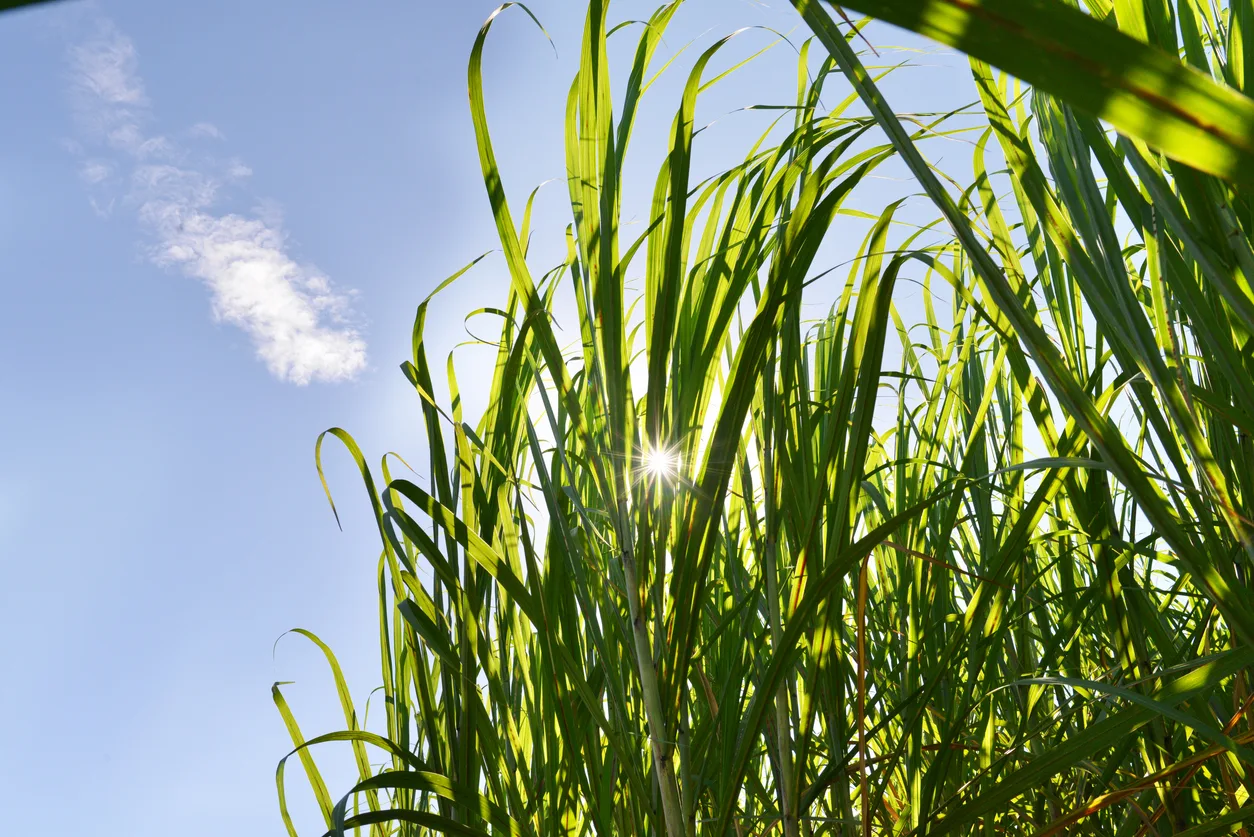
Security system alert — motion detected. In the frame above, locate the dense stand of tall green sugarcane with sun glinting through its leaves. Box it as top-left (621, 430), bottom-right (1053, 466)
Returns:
top-left (273, 0), bottom-right (1254, 837)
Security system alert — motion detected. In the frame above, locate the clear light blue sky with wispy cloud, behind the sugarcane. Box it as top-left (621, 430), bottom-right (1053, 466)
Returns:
top-left (0, 0), bottom-right (973, 837)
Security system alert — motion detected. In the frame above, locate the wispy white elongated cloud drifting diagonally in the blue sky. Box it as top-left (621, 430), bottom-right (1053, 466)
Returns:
top-left (69, 21), bottom-right (366, 384)
